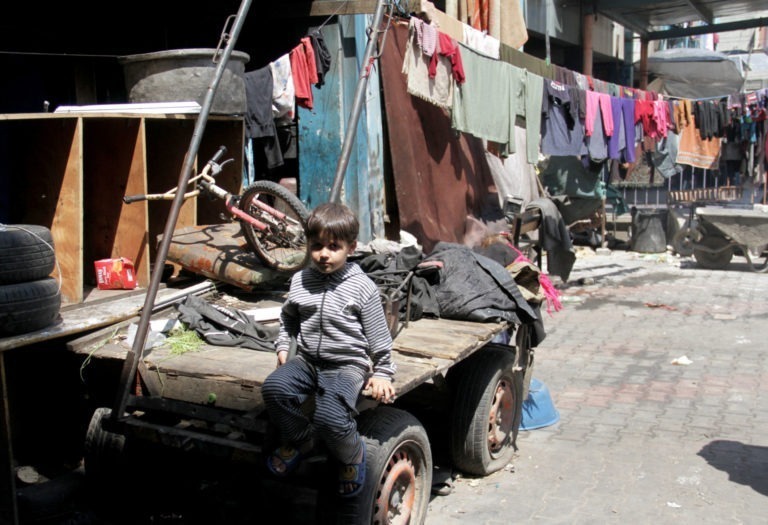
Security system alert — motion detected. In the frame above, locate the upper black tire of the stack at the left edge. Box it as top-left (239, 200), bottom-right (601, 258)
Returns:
top-left (0, 224), bottom-right (56, 284)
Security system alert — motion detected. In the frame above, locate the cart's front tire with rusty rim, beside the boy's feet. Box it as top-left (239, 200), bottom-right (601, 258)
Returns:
top-left (318, 407), bottom-right (432, 525)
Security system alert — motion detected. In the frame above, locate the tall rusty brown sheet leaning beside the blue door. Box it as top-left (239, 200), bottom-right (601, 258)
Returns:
top-left (380, 22), bottom-right (503, 252)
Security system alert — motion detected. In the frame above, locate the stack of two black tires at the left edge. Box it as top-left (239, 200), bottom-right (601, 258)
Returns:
top-left (0, 224), bottom-right (61, 337)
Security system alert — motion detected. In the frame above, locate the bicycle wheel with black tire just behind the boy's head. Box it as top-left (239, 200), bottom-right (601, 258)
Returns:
top-left (238, 180), bottom-right (309, 272)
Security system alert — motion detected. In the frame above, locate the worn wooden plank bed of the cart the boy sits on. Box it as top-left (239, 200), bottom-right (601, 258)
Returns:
top-left (67, 302), bottom-right (508, 412)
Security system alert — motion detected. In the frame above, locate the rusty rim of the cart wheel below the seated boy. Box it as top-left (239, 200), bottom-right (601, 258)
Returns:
top-left (373, 443), bottom-right (419, 525)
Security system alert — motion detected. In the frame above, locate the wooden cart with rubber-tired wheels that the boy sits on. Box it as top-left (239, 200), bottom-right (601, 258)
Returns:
top-left (68, 225), bottom-right (533, 523)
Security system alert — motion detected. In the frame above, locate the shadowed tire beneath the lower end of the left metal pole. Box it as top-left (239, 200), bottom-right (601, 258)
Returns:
top-left (83, 407), bottom-right (126, 493)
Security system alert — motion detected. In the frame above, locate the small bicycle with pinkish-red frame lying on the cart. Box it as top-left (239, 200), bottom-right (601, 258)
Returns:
top-left (123, 146), bottom-right (309, 272)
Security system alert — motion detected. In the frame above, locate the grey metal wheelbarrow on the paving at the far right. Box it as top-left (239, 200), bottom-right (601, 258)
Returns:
top-left (690, 205), bottom-right (768, 273)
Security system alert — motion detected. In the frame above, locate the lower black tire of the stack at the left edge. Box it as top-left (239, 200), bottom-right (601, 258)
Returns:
top-left (0, 277), bottom-right (61, 335)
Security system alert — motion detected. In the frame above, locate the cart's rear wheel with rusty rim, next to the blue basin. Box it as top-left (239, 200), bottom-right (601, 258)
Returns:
top-left (450, 345), bottom-right (522, 476)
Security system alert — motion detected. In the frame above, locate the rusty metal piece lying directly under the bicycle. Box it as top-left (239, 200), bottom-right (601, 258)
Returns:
top-left (167, 223), bottom-right (290, 291)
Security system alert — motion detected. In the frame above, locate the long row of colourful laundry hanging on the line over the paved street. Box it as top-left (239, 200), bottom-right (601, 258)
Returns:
top-left (403, 13), bottom-right (768, 172)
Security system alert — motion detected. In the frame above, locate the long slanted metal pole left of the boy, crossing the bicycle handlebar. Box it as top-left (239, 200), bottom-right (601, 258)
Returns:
top-left (111, 0), bottom-right (251, 420)
